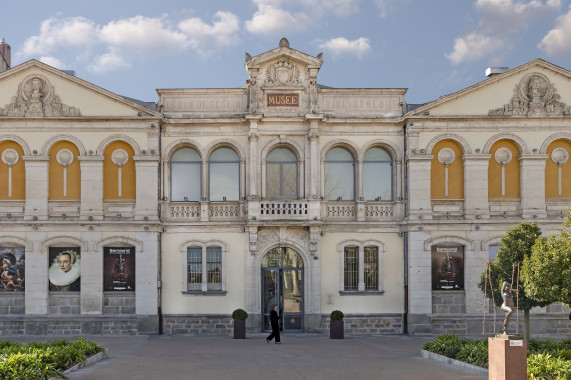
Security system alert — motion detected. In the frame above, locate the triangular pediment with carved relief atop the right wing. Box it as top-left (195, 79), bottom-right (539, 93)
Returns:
top-left (407, 59), bottom-right (571, 117)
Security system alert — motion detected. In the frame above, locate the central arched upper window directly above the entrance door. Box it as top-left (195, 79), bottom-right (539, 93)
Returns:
top-left (266, 148), bottom-right (298, 199)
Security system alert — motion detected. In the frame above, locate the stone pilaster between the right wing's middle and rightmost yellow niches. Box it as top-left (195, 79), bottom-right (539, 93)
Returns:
top-left (520, 154), bottom-right (549, 219)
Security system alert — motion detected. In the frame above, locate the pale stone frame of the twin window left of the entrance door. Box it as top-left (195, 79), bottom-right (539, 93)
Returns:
top-left (180, 240), bottom-right (228, 295)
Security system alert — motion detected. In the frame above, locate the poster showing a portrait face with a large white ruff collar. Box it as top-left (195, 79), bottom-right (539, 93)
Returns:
top-left (48, 247), bottom-right (81, 292)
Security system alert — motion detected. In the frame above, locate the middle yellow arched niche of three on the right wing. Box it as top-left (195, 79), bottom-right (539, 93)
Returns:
top-left (488, 140), bottom-right (520, 199)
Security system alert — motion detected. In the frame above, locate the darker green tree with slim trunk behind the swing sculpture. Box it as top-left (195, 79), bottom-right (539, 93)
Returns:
top-left (478, 223), bottom-right (550, 339)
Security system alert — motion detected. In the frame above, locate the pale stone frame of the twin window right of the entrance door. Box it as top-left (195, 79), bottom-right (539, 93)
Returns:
top-left (337, 240), bottom-right (385, 296)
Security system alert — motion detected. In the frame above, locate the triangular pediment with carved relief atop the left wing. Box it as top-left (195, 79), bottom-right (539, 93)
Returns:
top-left (0, 60), bottom-right (160, 118)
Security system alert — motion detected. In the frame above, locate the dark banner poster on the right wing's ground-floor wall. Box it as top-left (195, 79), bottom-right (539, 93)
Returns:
top-left (431, 245), bottom-right (464, 290)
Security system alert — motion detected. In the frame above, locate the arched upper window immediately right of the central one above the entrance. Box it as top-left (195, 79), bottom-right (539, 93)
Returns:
top-left (325, 148), bottom-right (355, 201)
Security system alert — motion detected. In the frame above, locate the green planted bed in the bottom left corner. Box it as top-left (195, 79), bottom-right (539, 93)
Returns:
top-left (0, 338), bottom-right (105, 380)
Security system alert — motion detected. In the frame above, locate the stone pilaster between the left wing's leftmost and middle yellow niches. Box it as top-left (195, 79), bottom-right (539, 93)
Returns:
top-left (22, 156), bottom-right (50, 220)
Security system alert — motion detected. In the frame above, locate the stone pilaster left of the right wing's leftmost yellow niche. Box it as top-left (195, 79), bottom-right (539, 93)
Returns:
top-left (408, 155), bottom-right (433, 219)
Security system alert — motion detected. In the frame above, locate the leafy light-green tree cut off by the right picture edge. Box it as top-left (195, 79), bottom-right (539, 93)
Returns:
top-left (522, 211), bottom-right (571, 307)
